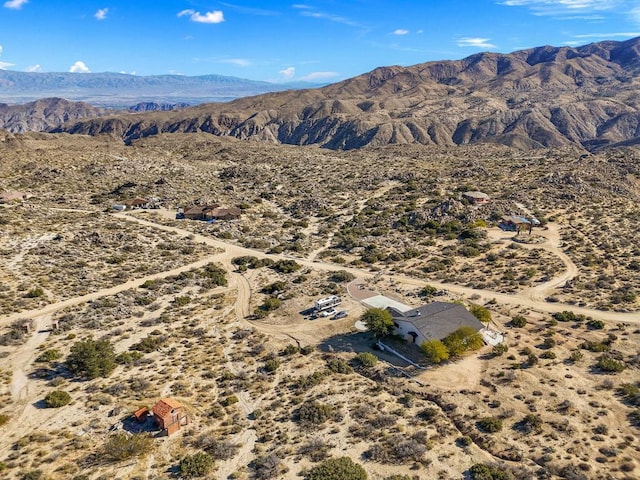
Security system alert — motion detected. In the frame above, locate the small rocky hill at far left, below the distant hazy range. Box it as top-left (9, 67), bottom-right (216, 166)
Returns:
top-left (0, 98), bottom-right (112, 133)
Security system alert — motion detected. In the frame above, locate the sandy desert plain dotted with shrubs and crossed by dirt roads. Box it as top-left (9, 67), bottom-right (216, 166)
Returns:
top-left (0, 128), bottom-right (640, 480)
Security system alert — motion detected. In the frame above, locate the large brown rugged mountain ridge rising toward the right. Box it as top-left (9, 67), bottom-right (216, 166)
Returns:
top-left (56, 38), bottom-right (640, 150)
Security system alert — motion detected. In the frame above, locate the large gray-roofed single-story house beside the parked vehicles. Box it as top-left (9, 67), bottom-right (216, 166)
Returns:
top-left (387, 302), bottom-right (484, 345)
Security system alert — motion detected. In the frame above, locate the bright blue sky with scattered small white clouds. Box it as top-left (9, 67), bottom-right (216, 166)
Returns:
top-left (0, 0), bottom-right (640, 82)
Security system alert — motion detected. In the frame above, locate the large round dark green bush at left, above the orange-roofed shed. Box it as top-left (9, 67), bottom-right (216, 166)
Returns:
top-left (65, 339), bottom-right (116, 380)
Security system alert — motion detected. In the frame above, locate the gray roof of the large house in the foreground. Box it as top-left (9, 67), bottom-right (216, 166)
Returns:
top-left (387, 302), bottom-right (484, 340)
